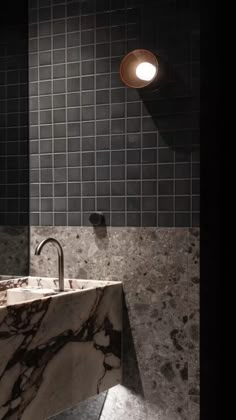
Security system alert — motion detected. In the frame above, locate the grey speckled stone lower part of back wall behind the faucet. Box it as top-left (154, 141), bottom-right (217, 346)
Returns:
top-left (31, 227), bottom-right (199, 420)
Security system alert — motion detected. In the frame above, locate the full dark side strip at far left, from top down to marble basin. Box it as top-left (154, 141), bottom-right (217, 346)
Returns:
top-left (0, 0), bottom-right (29, 276)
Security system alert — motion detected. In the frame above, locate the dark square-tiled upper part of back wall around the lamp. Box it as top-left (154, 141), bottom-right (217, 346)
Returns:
top-left (29, 0), bottom-right (199, 227)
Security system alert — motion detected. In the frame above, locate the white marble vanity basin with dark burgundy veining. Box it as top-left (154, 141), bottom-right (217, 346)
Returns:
top-left (0, 277), bottom-right (123, 420)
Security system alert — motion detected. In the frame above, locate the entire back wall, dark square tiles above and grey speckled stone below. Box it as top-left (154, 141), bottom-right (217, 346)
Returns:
top-left (29, 0), bottom-right (199, 420)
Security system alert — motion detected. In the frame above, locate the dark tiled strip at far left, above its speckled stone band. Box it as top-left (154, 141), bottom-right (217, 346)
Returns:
top-left (0, 1), bottom-right (29, 226)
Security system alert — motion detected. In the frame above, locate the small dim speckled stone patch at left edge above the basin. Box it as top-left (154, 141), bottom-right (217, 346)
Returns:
top-left (0, 226), bottom-right (29, 280)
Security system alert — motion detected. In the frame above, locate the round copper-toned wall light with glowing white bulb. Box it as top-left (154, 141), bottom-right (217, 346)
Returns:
top-left (120, 49), bottom-right (159, 89)
